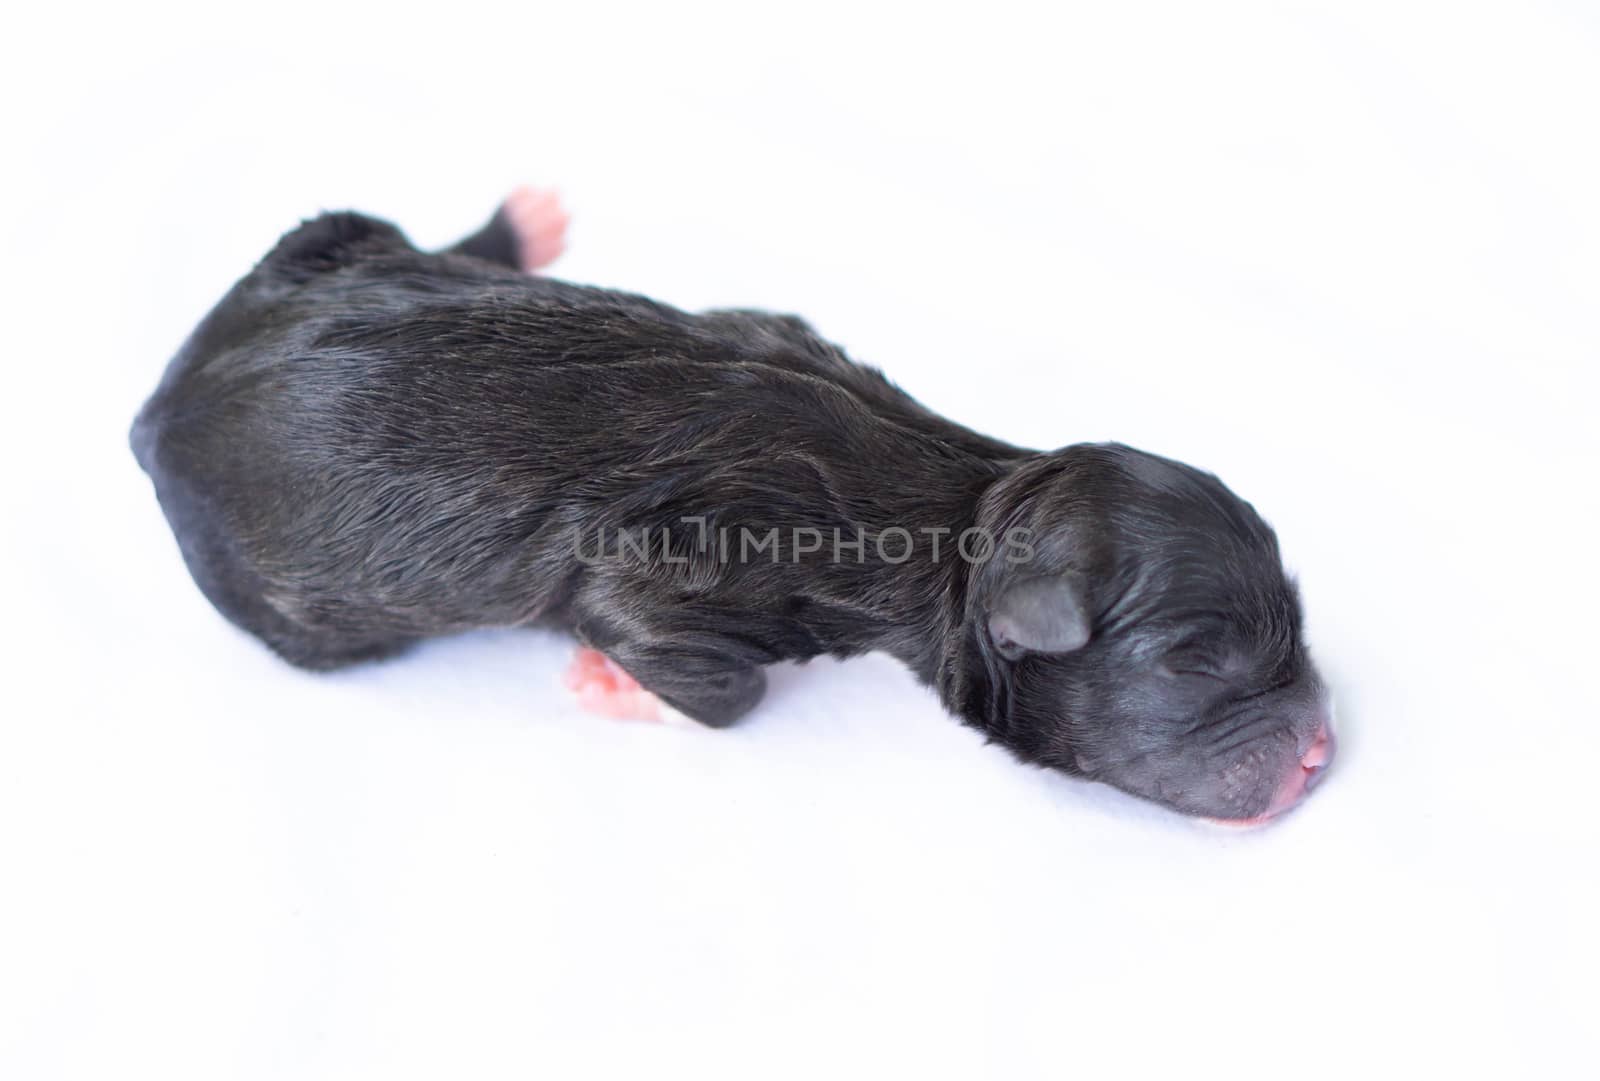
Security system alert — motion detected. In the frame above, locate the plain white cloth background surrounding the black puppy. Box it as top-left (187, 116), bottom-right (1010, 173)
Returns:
top-left (0, 2), bottom-right (1600, 1081)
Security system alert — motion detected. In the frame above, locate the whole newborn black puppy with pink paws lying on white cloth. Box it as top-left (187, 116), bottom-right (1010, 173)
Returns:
top-left (131, 189), bottom-right (1333, 822)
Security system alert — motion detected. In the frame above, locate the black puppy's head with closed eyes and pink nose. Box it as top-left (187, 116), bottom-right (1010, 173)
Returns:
top-left (966, 445), bottom-right (1333, 822)
